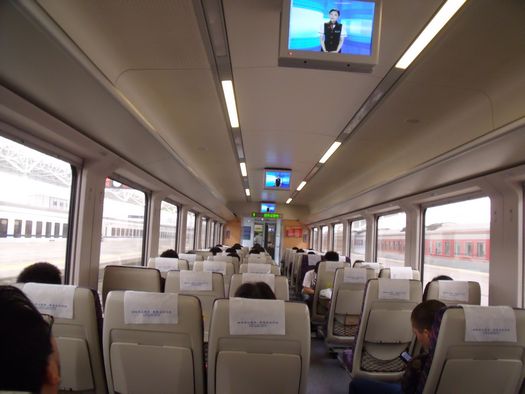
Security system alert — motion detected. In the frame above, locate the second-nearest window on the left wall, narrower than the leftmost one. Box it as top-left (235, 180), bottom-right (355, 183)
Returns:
top-left (99, 178), bottom-right (146, 290)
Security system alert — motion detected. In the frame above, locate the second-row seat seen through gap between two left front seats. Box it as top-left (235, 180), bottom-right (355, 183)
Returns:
top-left (164, 271), bottom-right (222, 342)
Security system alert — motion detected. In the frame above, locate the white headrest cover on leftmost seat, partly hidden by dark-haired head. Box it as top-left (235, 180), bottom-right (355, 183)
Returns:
top-left (23, 283), bottom-right (76, 319)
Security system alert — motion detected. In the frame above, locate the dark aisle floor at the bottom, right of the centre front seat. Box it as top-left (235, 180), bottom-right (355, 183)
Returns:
top-left (307, 338), bottom-right (350, 394)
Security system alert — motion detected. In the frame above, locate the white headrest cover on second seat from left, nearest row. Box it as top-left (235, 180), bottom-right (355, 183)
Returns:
top-left (124, 291), bottom-right (179, 324)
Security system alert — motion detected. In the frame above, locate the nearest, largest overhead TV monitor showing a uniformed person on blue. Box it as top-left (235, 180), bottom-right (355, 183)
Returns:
top-left (279, 0), bottom-right (381, 72)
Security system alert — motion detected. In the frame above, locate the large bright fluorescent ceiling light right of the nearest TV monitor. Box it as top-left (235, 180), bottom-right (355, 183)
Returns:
top-left (396, 0), bottom-right (467, 70)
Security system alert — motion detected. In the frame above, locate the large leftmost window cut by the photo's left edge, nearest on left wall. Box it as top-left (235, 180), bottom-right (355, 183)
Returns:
top-left (0, 137), bottom-right (74, 283)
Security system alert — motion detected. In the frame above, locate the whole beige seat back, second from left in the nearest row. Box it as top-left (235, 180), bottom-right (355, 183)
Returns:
top-left (104, 290), bottom-right (204, 394)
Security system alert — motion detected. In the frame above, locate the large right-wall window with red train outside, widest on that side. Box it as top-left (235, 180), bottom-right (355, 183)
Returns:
top-left (423, 197), bottom-right (490, 305)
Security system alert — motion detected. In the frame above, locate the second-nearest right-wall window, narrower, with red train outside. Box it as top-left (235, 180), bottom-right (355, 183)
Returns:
top-left (376, 212), bottom-right (408, 267)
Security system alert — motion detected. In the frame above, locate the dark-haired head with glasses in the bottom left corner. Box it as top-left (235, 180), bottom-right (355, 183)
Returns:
top-left (0, 286), bottom-right (60, 393)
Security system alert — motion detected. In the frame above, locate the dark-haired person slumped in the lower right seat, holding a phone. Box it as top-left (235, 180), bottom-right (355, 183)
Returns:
top-left (350, 300), bottom-right (446, 394)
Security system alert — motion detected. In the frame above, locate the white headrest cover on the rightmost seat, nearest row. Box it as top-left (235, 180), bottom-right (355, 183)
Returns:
top-left (461, 305), bottom-right (518, 342)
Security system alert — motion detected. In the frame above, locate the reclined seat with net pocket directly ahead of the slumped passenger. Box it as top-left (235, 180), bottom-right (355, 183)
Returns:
top-left (351, 278), bottom-right (422, 381)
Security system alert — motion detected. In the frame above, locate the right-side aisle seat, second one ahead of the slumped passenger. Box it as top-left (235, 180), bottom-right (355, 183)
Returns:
top-left (325, 268), bottom-right (377, 347)
